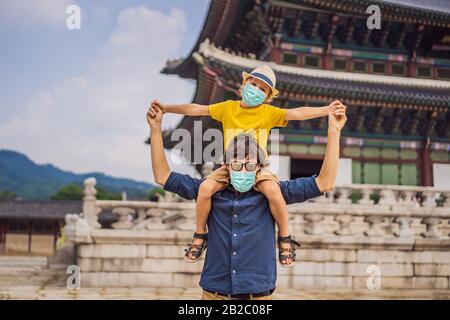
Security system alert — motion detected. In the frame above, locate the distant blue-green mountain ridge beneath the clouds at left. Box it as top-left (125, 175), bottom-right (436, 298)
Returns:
top-left (0, 150), bottom-right (155, 200)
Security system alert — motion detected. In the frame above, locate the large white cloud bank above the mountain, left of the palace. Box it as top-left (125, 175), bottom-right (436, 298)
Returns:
top-left (0, 6), bottom-right (199, 181)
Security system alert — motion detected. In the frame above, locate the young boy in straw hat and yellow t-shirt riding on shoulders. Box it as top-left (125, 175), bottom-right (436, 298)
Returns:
top-left (149, 65), bottom-right (345, 267)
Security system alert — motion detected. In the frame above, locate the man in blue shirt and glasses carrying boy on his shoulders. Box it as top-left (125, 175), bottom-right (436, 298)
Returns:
top-left (147, 103), bottom-right (347, 300)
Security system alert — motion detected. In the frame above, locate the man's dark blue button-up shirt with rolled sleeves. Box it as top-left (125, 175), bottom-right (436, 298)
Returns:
top-left (164, 172), bottom-right (322, 294)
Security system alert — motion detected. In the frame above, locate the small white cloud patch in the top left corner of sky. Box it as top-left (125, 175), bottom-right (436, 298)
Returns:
top-left (0, 0), bottom-right (77, 26)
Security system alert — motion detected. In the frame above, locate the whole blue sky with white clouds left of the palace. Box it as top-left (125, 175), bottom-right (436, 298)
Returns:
top-left (0, 0), bottom-right (209, 180)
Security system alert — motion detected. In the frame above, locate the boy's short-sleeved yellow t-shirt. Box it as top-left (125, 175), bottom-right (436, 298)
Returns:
top-left (209, 100), bottom-right (288, 151)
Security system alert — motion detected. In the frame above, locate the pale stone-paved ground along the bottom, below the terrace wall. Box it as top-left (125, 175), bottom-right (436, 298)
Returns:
top-left (0, 257), bottom-right (450, 300)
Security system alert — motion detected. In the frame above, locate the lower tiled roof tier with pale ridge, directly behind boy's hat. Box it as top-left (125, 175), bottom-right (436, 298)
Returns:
top-left (197, 43), bottom-right (450, 107)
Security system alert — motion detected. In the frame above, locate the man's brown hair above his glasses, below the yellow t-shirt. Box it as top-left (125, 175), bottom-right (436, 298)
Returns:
top-left (225, 133), bottom-right (268, 166)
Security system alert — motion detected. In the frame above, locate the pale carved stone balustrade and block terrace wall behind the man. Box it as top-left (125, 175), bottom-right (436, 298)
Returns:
top-left (66, 179), bottom-right (450, 289)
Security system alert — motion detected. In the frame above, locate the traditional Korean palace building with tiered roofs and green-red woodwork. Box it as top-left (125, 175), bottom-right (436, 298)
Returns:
top-left (162, 0), bottom-right (450, 187)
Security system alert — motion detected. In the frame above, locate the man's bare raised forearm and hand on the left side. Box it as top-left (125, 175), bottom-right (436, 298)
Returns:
top-left (147, 109), bottom-right (170, 186)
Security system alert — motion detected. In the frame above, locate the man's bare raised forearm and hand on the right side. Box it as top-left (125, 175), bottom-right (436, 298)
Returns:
top-left (316, 108), bottom-right (347, 192)
